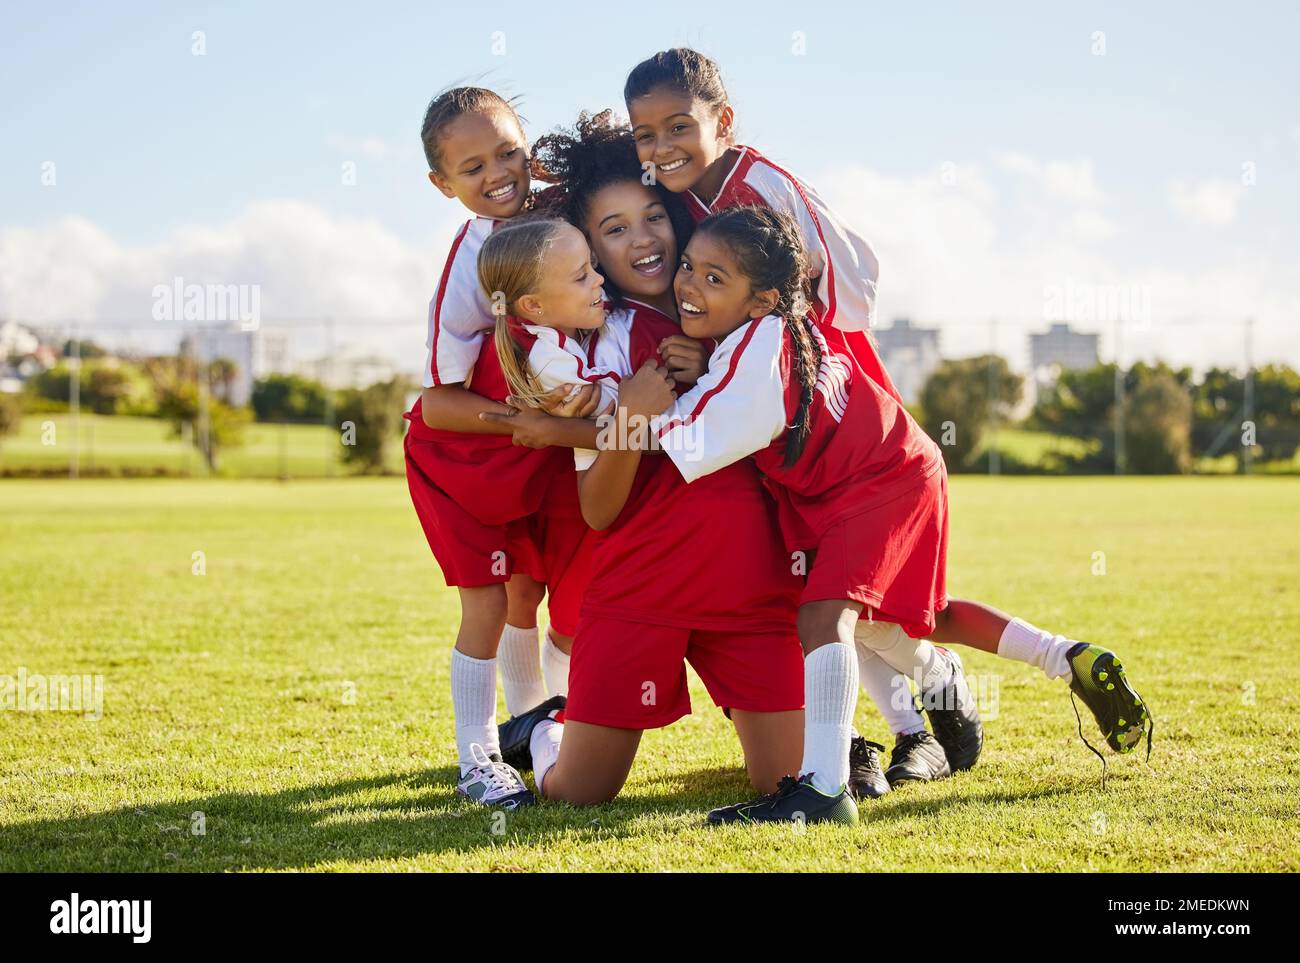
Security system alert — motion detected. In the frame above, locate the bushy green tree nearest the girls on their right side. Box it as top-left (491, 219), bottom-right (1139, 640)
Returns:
top-left (920, 355), bottom-right (1024, 472)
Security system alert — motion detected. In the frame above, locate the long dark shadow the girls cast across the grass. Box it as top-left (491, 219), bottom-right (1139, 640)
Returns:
top-left (0, 767), bottom-right (748, 872)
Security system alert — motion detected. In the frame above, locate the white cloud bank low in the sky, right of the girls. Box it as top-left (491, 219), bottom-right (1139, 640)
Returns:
top-left (814, 155), bottom-right (1300, 366)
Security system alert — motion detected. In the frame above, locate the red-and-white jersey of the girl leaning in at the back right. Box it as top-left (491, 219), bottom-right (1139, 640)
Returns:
top-left (683, 146), bottom-right (902, 403)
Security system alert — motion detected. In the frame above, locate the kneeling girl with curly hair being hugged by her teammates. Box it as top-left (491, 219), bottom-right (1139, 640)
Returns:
top-left (481, 116), bottom-right (803, 803)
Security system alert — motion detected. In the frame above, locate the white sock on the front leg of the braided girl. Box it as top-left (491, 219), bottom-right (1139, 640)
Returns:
top-left (800, 642), bottom-right (858, 794)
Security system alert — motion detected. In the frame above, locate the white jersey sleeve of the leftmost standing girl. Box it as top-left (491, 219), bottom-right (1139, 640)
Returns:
top-left (424, 221), bottom-right (494, 387)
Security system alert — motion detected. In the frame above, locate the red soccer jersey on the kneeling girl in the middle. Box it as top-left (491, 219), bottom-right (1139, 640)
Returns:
top-left (584, 300), bottom-right (801, 630)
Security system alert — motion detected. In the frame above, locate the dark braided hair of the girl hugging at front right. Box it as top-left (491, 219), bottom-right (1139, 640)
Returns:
top-left (697, 205), bottom-right (822, 468)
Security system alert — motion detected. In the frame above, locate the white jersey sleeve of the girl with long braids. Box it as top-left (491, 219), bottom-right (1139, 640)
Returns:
top-left (653, 315), bottom-right (787, 482)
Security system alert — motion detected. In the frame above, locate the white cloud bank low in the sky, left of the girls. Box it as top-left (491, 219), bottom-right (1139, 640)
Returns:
top-left (0, 200), bottom-right (456, 360)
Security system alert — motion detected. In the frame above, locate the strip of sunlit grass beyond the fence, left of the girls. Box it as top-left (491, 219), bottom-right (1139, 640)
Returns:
top-left (0, 415), bottom-right (402, 478)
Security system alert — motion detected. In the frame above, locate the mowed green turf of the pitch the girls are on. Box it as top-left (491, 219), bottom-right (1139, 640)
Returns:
top-left (0, 477), bottom-right (1300, 871)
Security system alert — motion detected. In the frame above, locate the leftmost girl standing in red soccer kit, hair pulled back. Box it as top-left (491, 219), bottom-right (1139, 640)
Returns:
top-left (406, 87), bottom-right (598, 808)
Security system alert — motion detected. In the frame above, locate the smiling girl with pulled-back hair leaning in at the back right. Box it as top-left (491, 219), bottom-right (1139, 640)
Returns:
top-left (624, 48), bottom-right (1154, 782)
